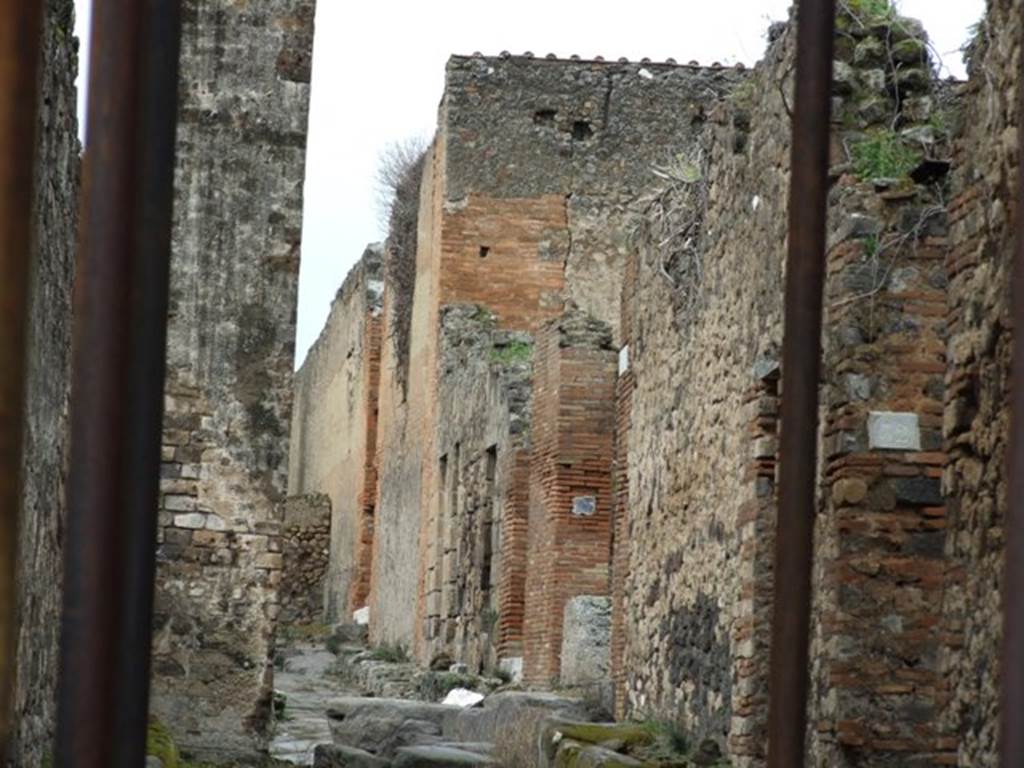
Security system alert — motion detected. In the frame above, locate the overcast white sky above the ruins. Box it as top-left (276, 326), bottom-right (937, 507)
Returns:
top-left (76, 0), bottom-right (984, 366)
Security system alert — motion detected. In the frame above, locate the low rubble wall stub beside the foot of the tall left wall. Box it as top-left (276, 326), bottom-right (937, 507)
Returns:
top-left (278, 494), bottom-right (331, 627)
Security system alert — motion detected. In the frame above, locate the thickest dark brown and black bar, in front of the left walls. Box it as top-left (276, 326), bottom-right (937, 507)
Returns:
top-left (56, 0), bottom-right (180, 768)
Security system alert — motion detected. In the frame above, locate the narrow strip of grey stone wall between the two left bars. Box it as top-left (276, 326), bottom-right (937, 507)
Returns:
top-left (9, 0), bottom-right (79, 768)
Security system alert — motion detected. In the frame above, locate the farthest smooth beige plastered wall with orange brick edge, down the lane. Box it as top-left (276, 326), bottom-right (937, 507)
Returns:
top-left (288, 245), bottom-right (384, 622)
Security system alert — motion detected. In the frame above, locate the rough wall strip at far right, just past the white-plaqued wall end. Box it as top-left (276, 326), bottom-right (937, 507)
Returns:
top-left (942, 0), bottom-right (1022, 768)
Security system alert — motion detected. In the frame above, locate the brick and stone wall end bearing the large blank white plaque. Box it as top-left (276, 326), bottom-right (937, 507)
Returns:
top-left (812, 183), bottom-right (955, 766)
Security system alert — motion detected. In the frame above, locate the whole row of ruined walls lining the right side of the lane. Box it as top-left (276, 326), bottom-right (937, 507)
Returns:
top-left (291, 0), bottom-right (1020, 766)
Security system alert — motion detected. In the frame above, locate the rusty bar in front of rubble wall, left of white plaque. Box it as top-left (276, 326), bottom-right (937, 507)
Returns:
top-left (768, 0), bottom-right (836, 768)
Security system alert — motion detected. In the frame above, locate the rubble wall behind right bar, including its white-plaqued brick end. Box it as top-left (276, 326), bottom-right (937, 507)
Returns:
top-left (613, 7), bottom-right (950, 766)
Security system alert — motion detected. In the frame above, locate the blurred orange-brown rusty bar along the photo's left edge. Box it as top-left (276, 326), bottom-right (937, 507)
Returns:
top-left (0, 0), bottom-right (43, 756)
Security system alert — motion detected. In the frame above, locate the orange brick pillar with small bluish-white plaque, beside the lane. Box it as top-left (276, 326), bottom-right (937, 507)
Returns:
top-left (523, 310), bottom-right (616, 685)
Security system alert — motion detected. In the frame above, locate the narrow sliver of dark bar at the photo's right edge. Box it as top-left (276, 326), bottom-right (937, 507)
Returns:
top-left (999, 6), bottom-right (1024, 766)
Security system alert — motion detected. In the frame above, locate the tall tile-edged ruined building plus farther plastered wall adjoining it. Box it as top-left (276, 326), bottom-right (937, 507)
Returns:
top-left (290, 56), bottom-right (739, 681)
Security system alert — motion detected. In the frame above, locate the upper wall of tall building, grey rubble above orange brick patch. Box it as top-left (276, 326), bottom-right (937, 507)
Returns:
top-left (441, 56), bottom-right (738, 337)
